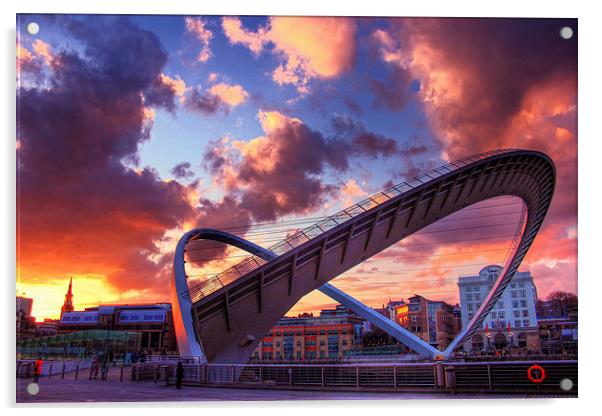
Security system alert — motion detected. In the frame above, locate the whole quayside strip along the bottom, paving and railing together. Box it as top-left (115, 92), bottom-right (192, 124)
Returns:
top-left (16, 361), bottom-right (577, 403)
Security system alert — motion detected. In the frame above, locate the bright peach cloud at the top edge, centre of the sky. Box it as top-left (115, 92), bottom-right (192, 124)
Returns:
top-left (222, 17), bottom-right (356, 93)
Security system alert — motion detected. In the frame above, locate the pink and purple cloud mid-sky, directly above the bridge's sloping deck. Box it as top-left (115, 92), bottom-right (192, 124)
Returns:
top-left (204, 111), bottom-right (396, 220)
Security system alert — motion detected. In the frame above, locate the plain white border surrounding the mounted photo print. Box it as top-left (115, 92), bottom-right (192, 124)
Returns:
top-left (0, 0), bottom-right (602, 416)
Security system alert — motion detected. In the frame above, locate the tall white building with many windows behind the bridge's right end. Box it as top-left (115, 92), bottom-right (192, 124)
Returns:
top-left (458, 265), bottom-right (537, 350)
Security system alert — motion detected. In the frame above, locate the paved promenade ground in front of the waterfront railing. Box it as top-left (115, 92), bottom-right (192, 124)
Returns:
top-left (16, 368), bottom-right (562, 403)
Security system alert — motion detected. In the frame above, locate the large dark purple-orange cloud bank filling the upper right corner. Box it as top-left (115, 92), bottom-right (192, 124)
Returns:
top-left (372, 19), bottom-right (577, 300)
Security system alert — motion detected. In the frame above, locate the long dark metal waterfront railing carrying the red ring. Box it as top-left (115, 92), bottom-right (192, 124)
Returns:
top-left (152, 360), bottom-right (578, 394)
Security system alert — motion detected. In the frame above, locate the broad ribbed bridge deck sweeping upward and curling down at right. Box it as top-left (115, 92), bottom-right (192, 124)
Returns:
top-left (172, 149), bottom-right (556, 363)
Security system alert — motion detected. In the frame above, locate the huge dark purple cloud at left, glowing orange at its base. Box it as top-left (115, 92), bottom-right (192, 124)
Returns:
top-left (17, 16), bottom-right (194, 300)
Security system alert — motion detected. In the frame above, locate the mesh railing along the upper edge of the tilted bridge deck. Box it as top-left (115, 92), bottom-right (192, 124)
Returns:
top-left (181, 149), bottom-right (514, 302)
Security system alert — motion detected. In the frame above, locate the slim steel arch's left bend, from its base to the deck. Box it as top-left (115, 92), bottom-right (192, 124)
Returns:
top-left (171, 228), bottom-right (277, 361)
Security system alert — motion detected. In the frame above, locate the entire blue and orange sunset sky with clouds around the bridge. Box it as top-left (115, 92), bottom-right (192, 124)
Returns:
top-left (17, 15), bottom-right (578, 320)
